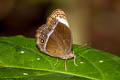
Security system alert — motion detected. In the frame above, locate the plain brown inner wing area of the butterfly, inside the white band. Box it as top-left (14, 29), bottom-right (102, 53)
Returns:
top-left (46, 22), bottom-right (72, 58)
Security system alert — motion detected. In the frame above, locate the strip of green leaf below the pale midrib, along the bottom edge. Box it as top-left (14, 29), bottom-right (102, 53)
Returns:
top-left (0, 68), bottom-right (90, 80)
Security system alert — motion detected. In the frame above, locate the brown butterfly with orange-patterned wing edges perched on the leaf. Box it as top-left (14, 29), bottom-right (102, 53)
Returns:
top-left (36, 9), bottom-right (77, 70)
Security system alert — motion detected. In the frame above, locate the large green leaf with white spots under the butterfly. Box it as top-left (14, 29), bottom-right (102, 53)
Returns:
top-left (0, 36), bottom-right (120, 80)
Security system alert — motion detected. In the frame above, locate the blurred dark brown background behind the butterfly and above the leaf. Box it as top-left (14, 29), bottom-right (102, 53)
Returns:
top-left (0, 0), bottom-right (120, 56)
